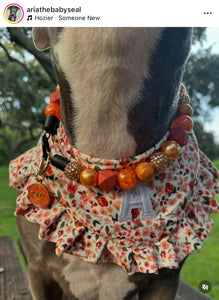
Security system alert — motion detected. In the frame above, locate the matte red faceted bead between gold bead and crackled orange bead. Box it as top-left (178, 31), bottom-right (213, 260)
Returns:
top-left (97, 170), bottom-right (116, 192)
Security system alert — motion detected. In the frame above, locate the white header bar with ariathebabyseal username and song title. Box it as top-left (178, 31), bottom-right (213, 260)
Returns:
top-left (0, 0), bottom-right (219, 27)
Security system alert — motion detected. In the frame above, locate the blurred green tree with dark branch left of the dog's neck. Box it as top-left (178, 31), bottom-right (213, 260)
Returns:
top-left (0, 28), bottom-right (55, 164)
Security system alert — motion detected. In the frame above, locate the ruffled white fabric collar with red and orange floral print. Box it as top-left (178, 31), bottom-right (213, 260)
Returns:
top-left (10, 126), bottom-right (219, 274)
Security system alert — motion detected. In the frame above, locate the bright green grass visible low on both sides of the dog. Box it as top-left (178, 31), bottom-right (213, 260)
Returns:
top-left (0, 164), bottom-right (219, 300)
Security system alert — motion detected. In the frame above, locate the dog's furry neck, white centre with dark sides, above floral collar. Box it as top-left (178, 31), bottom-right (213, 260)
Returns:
top-left (53, 28), bottom-right (191, 158)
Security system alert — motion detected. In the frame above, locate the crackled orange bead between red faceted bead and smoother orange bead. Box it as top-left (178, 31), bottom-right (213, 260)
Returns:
top-left (117, 168), bottom-right (137, 189)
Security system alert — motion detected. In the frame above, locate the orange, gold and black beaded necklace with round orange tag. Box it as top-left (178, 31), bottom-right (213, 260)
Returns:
top-left (28, 85), bottom-right (193, 207)
